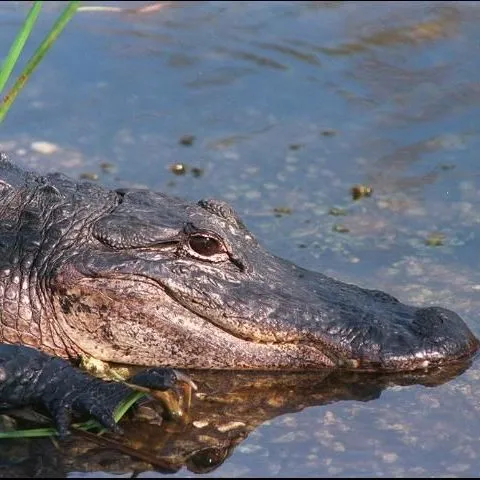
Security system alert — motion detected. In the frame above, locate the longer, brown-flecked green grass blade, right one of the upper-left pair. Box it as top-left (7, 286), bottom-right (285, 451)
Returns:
top-left (0, 1), bottom-right (80, 123)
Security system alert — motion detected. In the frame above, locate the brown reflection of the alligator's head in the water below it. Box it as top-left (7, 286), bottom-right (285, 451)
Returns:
top-left (0, 363), bottom-right (469, 477)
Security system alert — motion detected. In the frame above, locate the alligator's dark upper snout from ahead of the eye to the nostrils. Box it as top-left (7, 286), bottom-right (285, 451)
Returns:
top-left (204, 257), bottom-right (479, 371)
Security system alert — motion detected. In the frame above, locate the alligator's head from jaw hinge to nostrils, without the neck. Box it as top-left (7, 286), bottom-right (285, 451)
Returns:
top-left (43, 184), bottom-right (478, 371)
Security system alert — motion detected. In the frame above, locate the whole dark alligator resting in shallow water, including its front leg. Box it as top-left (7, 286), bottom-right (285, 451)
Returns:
top-left (0, 155), bottom-right (479, 434)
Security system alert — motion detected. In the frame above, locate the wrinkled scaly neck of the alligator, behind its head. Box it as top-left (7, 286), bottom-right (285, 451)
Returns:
top-left (0, 169), bottom-right (116, 357)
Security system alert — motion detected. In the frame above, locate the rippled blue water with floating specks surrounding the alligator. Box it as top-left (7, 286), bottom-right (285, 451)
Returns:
top-left (0, 2), bottom-right (480, 476)
